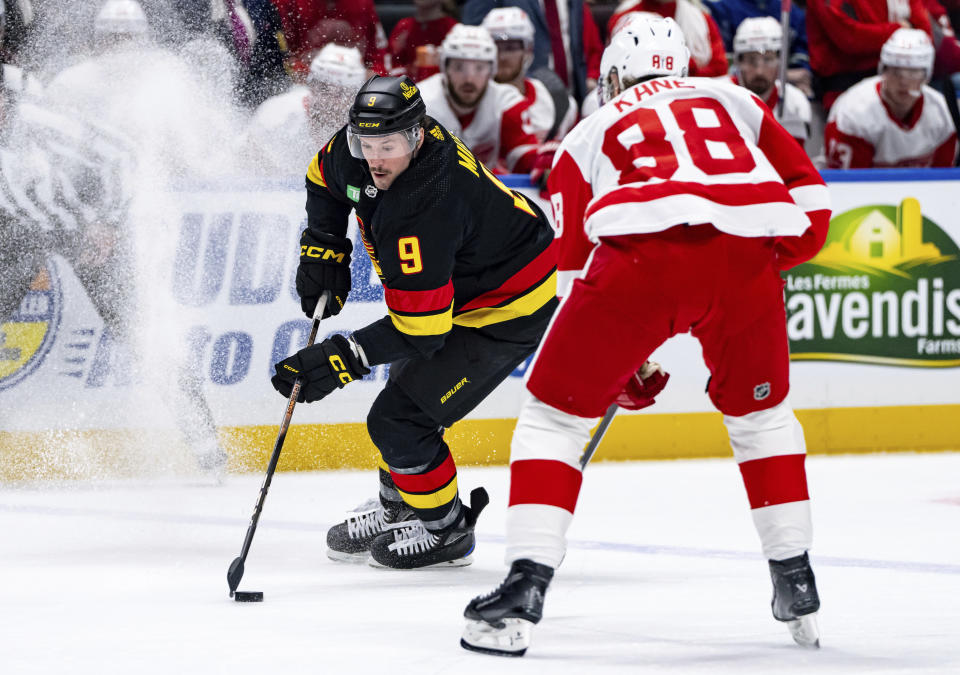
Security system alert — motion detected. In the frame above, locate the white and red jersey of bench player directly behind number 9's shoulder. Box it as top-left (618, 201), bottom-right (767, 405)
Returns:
top-left (420, 73), bottom-right (539, 173)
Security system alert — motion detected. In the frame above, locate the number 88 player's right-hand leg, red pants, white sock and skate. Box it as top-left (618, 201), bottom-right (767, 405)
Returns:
top-left (693, 242), bottom-right (820, 646)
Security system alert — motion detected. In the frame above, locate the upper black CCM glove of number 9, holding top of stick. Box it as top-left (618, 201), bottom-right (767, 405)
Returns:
top-left (297, 230), bottom-right (353, 319)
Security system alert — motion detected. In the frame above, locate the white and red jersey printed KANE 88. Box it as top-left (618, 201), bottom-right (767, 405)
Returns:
top-left (548, 77), bottom-right (830, 288)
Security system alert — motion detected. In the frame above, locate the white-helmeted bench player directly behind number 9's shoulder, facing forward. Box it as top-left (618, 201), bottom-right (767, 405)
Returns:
top-left (419, 23), bottom-right (539, 173)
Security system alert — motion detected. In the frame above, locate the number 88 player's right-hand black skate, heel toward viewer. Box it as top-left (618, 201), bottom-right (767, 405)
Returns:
top-left (770, 553), bottom-right (820, 649)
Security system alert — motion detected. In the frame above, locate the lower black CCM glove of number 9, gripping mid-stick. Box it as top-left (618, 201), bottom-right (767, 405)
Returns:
top-left (270, 335), bottom-right (370, 403)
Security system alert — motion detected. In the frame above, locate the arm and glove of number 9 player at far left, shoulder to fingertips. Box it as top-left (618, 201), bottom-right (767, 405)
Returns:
top-left (296, 136), bottom-right (353, 318)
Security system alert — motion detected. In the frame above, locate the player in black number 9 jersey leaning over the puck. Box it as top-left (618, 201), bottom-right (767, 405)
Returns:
top-left (273, 76), bottom-right (557, 569)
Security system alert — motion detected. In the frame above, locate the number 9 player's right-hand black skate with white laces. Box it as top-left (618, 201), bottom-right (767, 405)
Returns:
top-left (370, 488), bottom-right (490, 570)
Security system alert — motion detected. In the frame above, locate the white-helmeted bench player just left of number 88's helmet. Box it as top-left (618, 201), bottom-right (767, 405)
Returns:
top-left (483, 7), bottom-right (577, 143)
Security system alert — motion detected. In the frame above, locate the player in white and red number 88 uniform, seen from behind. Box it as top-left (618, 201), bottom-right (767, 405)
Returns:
top-left (461, 18), bottom-right (830, 656)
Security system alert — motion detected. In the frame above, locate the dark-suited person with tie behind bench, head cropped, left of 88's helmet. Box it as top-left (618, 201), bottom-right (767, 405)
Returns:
top-left (463, 0), bottom-right (603, 104)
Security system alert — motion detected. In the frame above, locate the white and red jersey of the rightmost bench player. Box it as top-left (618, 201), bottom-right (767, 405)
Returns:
top-left (823, 75), bottom-right (957, 169)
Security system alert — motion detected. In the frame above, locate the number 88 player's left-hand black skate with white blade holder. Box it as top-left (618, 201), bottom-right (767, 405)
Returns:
top-left (460, 560), bottom-right (553, 656)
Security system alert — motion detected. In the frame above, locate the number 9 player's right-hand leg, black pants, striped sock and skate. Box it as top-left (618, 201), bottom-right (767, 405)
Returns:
top-left (367, 307), bottom-right (552, 569)
